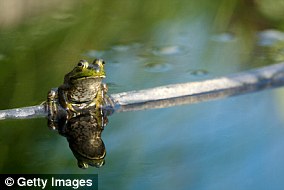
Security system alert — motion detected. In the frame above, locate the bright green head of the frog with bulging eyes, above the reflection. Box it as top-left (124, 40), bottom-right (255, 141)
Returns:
top-left (64, 59), bottom-right (106, 83)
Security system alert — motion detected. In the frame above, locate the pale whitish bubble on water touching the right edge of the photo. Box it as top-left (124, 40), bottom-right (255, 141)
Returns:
top-left (258, 30), bottom-right (284, 46)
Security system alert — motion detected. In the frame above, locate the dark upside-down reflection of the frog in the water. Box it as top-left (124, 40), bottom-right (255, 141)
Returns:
top-left (59, 110), bottom-right (108, 169)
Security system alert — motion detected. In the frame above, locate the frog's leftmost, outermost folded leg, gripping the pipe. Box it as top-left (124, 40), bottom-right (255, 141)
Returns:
top-left (45, 89), bottom-right (58, 130)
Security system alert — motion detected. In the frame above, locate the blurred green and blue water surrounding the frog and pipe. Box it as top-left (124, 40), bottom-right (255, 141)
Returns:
top-left (0, 0), bottom-right (284, 190)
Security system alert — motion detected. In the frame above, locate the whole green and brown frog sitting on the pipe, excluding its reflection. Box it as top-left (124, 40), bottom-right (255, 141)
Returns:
top-left (46, 59), bottom-right (110, 130)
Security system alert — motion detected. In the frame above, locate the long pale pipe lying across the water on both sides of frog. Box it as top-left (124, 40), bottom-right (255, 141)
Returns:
top-left (0, 62), bottom-right (284, 120)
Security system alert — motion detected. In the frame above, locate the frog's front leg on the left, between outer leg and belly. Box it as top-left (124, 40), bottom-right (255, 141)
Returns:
top-left (58, 85), bottom-right (77, 119)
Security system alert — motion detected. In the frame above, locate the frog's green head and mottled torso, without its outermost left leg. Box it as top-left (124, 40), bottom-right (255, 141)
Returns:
top-left (58, 59), bottom-right (107, 113)
